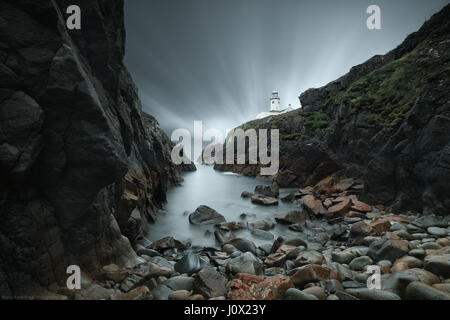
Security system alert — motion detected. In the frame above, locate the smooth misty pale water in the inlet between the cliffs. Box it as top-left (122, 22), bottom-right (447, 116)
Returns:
top-left (147, 165), bottom-right (304, 246)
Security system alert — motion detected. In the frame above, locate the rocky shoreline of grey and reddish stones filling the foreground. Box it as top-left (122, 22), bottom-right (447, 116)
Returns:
top-left (53, 177), bottom-right (450, 300)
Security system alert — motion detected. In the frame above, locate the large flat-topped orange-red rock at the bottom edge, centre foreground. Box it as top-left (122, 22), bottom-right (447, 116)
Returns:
top-left (227, 273), bottom-right (294, 300)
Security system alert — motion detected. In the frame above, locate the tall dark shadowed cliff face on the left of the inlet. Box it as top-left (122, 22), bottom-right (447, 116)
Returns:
top-left (0, 0), bottom-right (183, 295)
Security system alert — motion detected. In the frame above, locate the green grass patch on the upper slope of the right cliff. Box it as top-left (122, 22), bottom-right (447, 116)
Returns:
top-left (326, 35), bottom-right (450, 127)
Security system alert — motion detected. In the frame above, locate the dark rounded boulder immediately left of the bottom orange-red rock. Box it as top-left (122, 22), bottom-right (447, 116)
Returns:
top-left (194, 266), bottom-right (227, 298)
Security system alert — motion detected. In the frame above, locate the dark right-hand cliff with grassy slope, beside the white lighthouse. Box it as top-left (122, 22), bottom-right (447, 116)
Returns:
top-left (215, 5), bottom-right (450, 214)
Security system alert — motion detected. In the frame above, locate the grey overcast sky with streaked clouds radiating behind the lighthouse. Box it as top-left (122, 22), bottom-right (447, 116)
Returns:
top-left (125, 0), bottom-right (449, 135)
